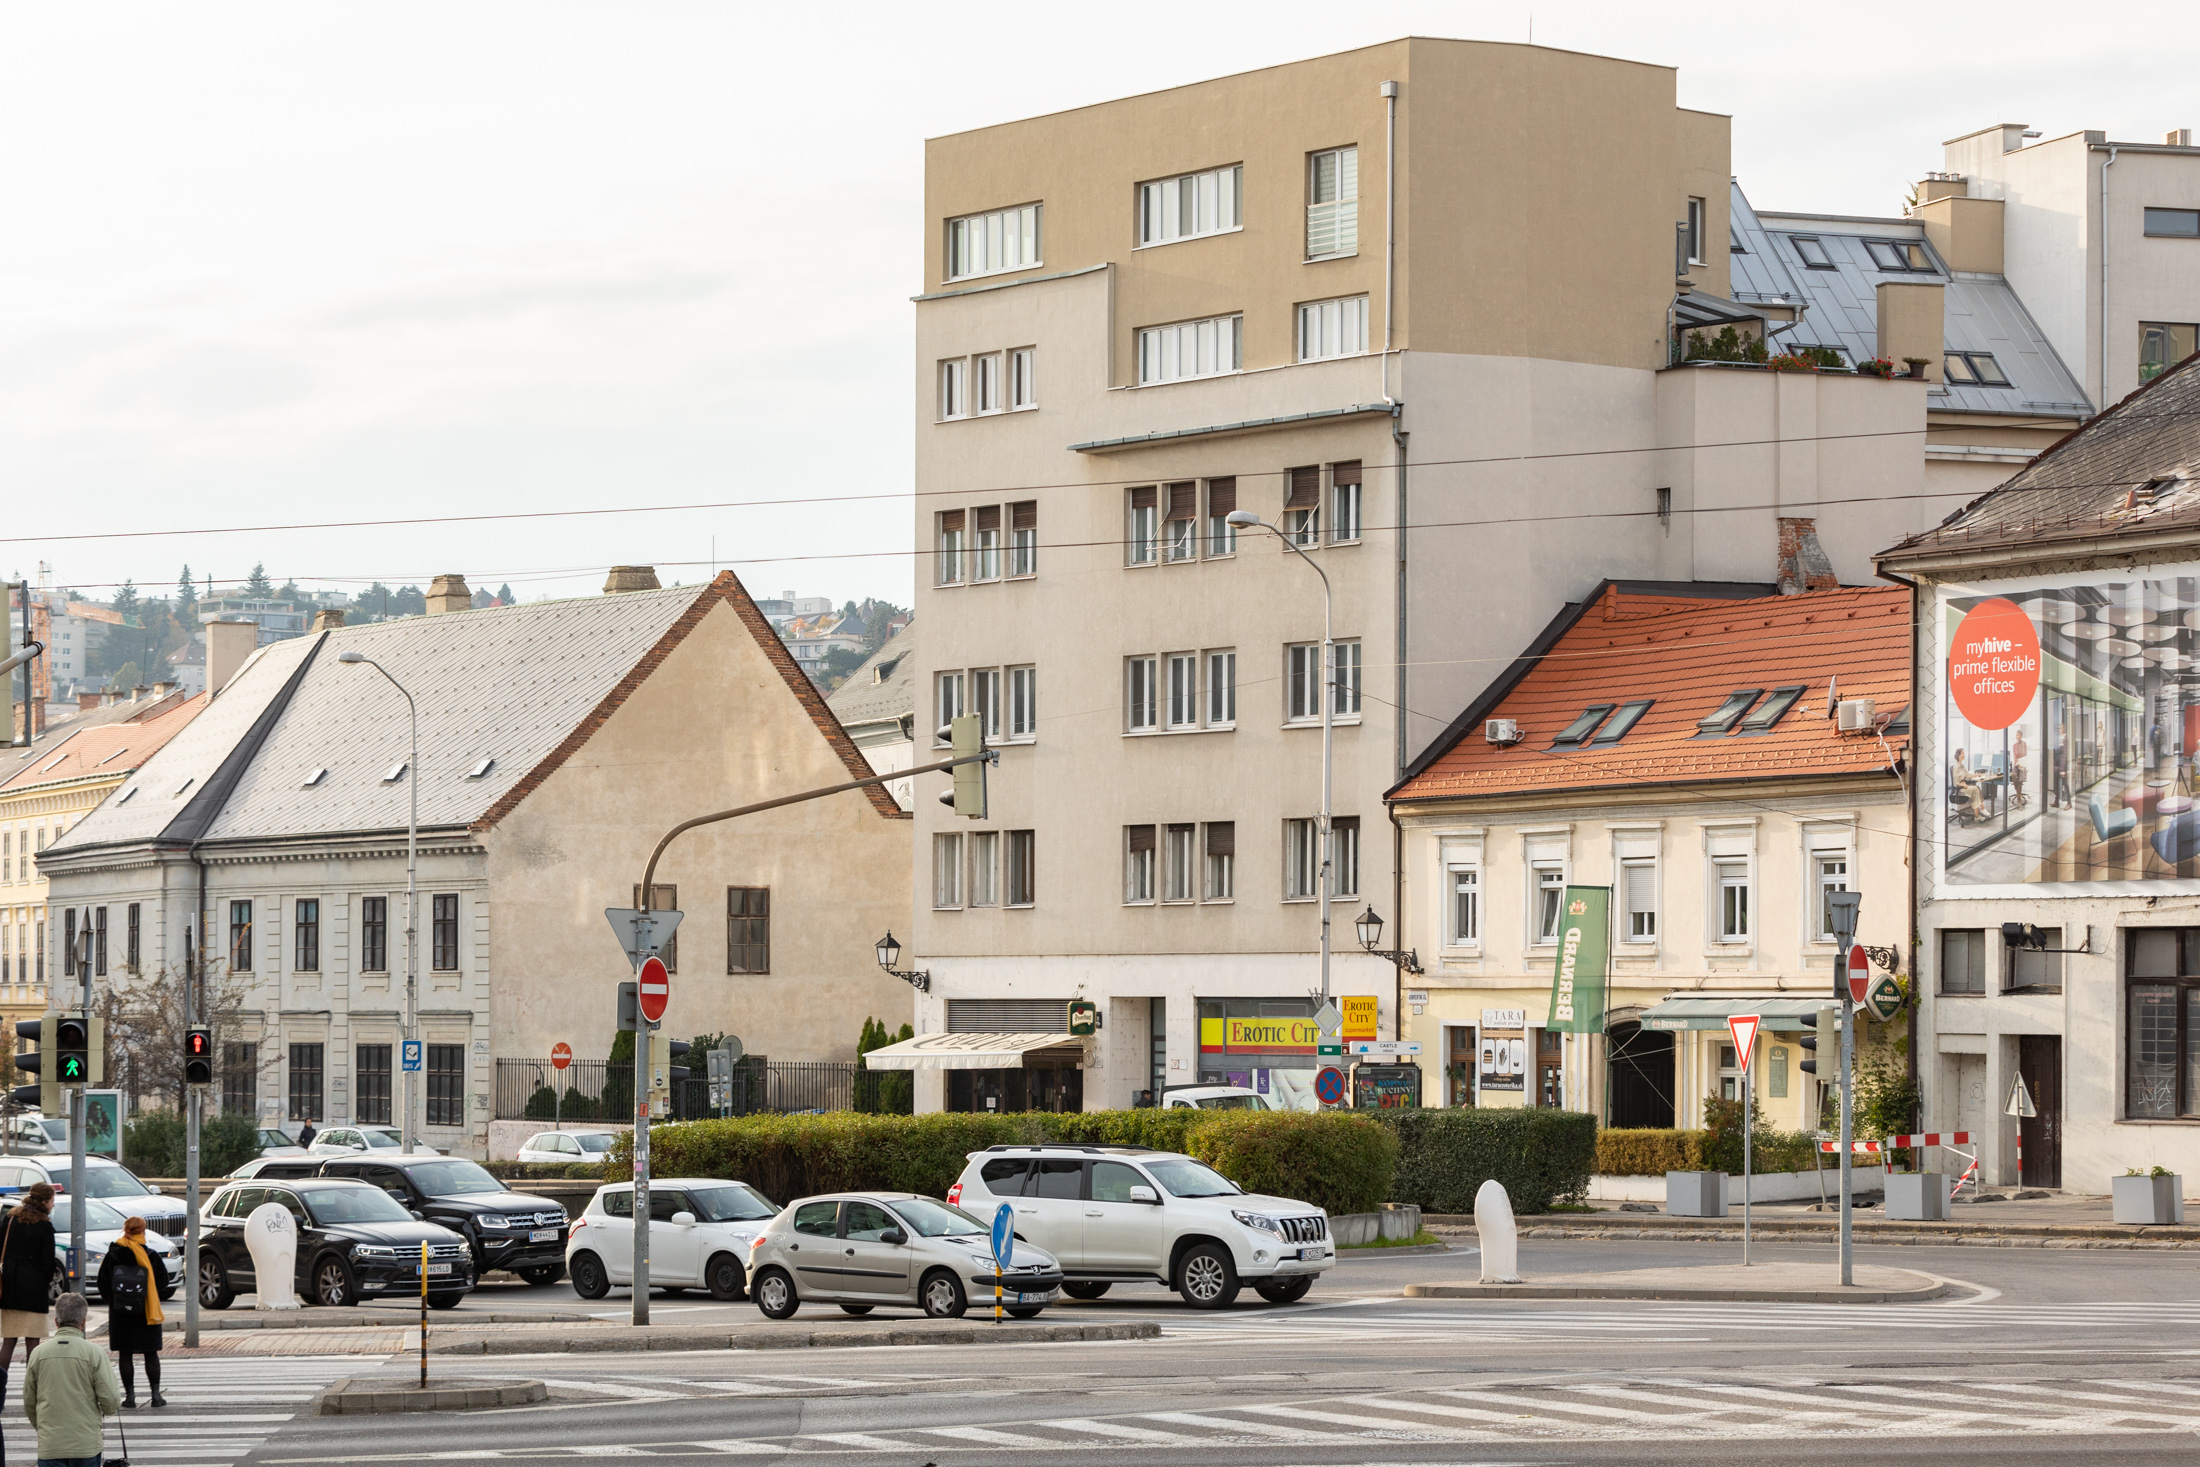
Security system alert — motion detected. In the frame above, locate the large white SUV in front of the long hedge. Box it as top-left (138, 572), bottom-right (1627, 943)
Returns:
top-left (948, 1146), bottom-right (1338, 1309)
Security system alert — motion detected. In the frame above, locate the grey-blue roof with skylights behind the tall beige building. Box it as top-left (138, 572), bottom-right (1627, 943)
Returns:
top-left (1731, 187), bottom-right (2092, 418)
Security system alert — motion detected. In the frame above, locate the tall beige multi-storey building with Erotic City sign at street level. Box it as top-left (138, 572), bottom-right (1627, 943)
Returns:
top-left (911, 40), bottom-right (1962, 1106)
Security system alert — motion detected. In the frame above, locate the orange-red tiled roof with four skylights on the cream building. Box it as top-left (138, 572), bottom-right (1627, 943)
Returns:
top-left (1390, 585), bottom-right (1910, 801)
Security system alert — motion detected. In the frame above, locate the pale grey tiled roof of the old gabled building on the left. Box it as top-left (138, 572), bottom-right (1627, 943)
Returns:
top-left (55, 585), bottom-right (706, 853)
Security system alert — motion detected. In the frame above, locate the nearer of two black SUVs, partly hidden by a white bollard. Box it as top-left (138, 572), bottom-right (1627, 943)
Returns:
top-left (198, 1177), bottom-right (475, 1309)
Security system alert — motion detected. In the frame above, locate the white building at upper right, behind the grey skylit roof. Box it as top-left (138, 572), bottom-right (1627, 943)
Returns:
top-left (1944, 123), bottom-right (2200, 415)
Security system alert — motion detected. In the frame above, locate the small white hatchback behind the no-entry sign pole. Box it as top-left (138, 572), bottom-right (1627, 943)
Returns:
top-left (565, 1177), bottom-right (779, 1300)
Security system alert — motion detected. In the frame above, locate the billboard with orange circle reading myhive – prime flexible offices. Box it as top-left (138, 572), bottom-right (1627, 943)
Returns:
top-left (1944, 565), bottom-right (2200, 897)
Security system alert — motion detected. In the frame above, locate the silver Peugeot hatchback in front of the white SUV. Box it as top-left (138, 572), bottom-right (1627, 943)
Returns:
top-left (748, 1192), bottom-right (1063, 1320)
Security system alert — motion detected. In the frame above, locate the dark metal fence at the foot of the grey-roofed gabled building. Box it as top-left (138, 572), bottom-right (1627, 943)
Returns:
top-left (497, 1056), bottom-right (880, 1122)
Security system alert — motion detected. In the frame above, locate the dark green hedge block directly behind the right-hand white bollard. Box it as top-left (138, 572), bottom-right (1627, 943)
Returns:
top-left (1366, 1106), bottom-right (1597, 1212)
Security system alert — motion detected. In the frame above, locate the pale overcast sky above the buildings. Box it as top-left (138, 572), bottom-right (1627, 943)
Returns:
top-left (0, 0), bottom-right (2200, 605)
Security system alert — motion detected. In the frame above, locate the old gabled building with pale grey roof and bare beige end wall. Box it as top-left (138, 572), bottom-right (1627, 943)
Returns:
top-left (42, 567), bottom-right (911, 1155)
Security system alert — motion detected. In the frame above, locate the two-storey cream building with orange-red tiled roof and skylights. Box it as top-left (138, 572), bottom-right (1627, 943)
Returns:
top-left (1390, 567), bottom-right (1910, 1130)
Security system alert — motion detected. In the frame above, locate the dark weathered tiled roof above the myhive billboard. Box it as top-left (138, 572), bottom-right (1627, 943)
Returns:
top-left (1881, 356), bottom-right (2200, 565)
